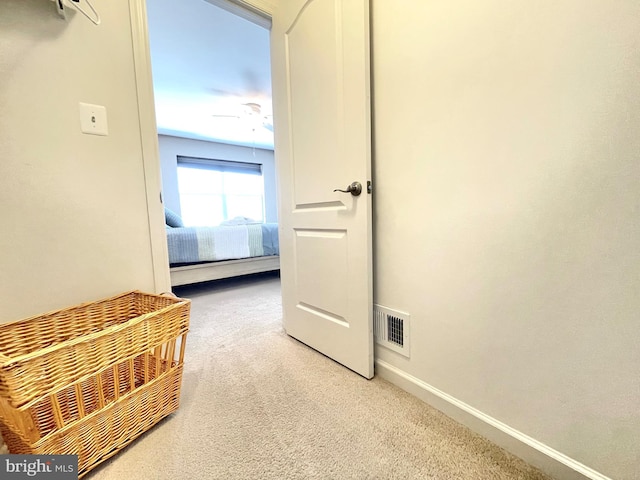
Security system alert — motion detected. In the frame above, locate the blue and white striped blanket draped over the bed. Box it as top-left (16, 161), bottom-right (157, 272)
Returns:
top-left (167, 223), bottom-right (280, 265)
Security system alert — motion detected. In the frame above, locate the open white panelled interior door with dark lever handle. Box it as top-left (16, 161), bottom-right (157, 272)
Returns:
top-left (271, 0), bottom-right (373, 378)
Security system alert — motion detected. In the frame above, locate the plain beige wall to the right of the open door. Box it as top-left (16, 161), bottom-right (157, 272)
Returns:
top-left (372, 0), bottom-right (640, 480)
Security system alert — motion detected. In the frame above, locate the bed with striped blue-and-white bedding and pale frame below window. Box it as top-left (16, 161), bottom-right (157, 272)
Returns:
top-left (167, 223), bottom-right (280, 287)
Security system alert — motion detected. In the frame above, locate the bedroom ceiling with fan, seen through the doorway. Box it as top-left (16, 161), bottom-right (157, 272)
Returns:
top-left (147, 0), bottom-right (273, 149)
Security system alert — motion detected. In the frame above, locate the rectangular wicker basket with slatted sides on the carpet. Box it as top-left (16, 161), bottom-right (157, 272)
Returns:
top-left (0, 291), bottom-right (190, 477)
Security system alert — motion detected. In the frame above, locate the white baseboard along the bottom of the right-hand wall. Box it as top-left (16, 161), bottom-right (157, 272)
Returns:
top-left (376, 360), bottom-right (611, 480)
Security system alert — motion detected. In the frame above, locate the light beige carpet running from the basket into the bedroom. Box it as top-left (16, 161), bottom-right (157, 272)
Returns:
top-left (85, 276), bottom-right (549, 480)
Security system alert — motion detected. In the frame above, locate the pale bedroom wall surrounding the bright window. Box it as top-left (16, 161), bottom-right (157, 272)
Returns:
top-left (158, 135), bottom-right (278, 223)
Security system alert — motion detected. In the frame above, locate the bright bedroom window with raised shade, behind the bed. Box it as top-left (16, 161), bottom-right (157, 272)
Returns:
top-left (178, 156), bottom-right (264, 227)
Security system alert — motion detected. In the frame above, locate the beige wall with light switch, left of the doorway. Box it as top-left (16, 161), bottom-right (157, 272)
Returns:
top-left (0, 0), bottom-right (161, 322)
